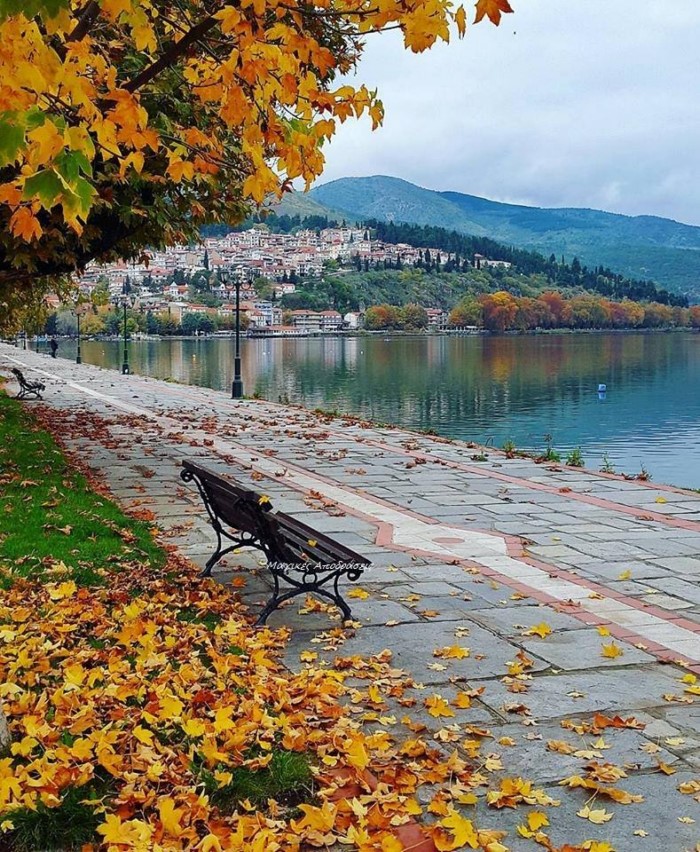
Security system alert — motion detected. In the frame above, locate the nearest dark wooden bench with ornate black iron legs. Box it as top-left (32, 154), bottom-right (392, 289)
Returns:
top-left (180, 460), bottom-right (371, 624)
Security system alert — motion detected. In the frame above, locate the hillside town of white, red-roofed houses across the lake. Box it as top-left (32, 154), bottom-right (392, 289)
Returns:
top-left (74, 226), bottom-right (509, 335)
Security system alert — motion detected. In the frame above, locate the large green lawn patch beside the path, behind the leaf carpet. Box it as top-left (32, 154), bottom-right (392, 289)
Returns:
top-left (0, 393), bottom-right (165, 588)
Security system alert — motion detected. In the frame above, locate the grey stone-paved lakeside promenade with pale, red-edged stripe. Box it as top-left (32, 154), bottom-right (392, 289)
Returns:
top-left (0, 344), bottom-right (700, 852)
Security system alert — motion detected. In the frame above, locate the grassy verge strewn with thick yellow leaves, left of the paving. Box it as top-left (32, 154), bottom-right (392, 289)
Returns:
top-left (0, 396), bottom-right (502, 852)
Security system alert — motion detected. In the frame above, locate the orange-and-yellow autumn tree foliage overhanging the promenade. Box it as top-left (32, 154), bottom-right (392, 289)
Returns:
top-left (0, 0), bottom-right (512, 330)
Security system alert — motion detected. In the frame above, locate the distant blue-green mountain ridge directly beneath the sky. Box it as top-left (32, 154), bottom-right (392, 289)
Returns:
top-left (306, 175), bottom-right (700, 298)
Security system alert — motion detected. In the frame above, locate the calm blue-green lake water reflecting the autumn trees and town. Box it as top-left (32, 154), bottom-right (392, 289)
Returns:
top-left (40, 333), bottom-right (700, 488)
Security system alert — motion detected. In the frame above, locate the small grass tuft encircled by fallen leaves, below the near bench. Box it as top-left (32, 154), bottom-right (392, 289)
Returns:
top-left (200, 749), bottom-right (313, 813)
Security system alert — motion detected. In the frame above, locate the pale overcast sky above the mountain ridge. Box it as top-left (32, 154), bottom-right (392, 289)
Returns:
top-left (320, 0), bottom-right (700, 225)
